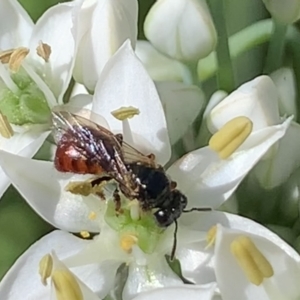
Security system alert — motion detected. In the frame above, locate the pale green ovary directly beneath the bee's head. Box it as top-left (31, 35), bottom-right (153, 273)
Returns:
top-left (105, 201), bottom-right (164, 254)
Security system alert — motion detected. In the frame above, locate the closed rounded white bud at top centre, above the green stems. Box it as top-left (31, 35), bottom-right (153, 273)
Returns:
top-left (144, 0), bottom-right (217, 61)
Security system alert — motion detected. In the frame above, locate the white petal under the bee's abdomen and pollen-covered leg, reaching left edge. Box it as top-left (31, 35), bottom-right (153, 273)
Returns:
top-left (0, 151), bottom-right (100, 232)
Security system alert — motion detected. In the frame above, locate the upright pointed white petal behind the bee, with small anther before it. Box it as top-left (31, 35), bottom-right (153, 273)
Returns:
top-left (93, 41), bottom-right (171, 164)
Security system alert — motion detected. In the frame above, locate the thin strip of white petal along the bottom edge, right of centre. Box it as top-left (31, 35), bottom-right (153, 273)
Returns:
top-left (133, 284), bottom-right (216, 300)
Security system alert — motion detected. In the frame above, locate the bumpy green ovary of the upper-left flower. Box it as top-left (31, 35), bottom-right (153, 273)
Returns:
top-left (0, 72), bottom-right (50, 125)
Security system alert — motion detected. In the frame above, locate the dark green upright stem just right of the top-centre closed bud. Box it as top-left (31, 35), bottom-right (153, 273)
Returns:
top-left (209, 0), bottom-right (235, 92)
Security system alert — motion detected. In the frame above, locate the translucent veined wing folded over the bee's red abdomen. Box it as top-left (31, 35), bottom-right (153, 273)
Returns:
top-left (52, 111), bottom-right (135, 191)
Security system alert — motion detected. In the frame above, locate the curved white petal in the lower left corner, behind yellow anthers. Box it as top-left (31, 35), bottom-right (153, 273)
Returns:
top-left (0, 231), bottom-right (89, 300)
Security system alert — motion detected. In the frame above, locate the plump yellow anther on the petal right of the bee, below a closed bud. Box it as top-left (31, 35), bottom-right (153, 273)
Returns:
top-left (209, 117), bottom-right (253, 159)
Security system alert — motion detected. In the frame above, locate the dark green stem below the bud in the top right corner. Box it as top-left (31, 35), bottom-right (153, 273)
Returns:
top-left (264, 21), bottom-right (288, 74)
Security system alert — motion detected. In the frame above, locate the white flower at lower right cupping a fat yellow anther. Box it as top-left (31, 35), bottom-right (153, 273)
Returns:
top-left (177, 212), bottom-right (300, 300)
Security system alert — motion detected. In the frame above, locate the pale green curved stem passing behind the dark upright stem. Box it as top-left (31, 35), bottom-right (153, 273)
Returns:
top-left (198, 19), bottom-right (274, 81)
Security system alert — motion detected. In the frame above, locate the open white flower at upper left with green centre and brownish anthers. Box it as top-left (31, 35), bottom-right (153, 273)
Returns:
top-left (0, 0), bottom-right (75, 195)
